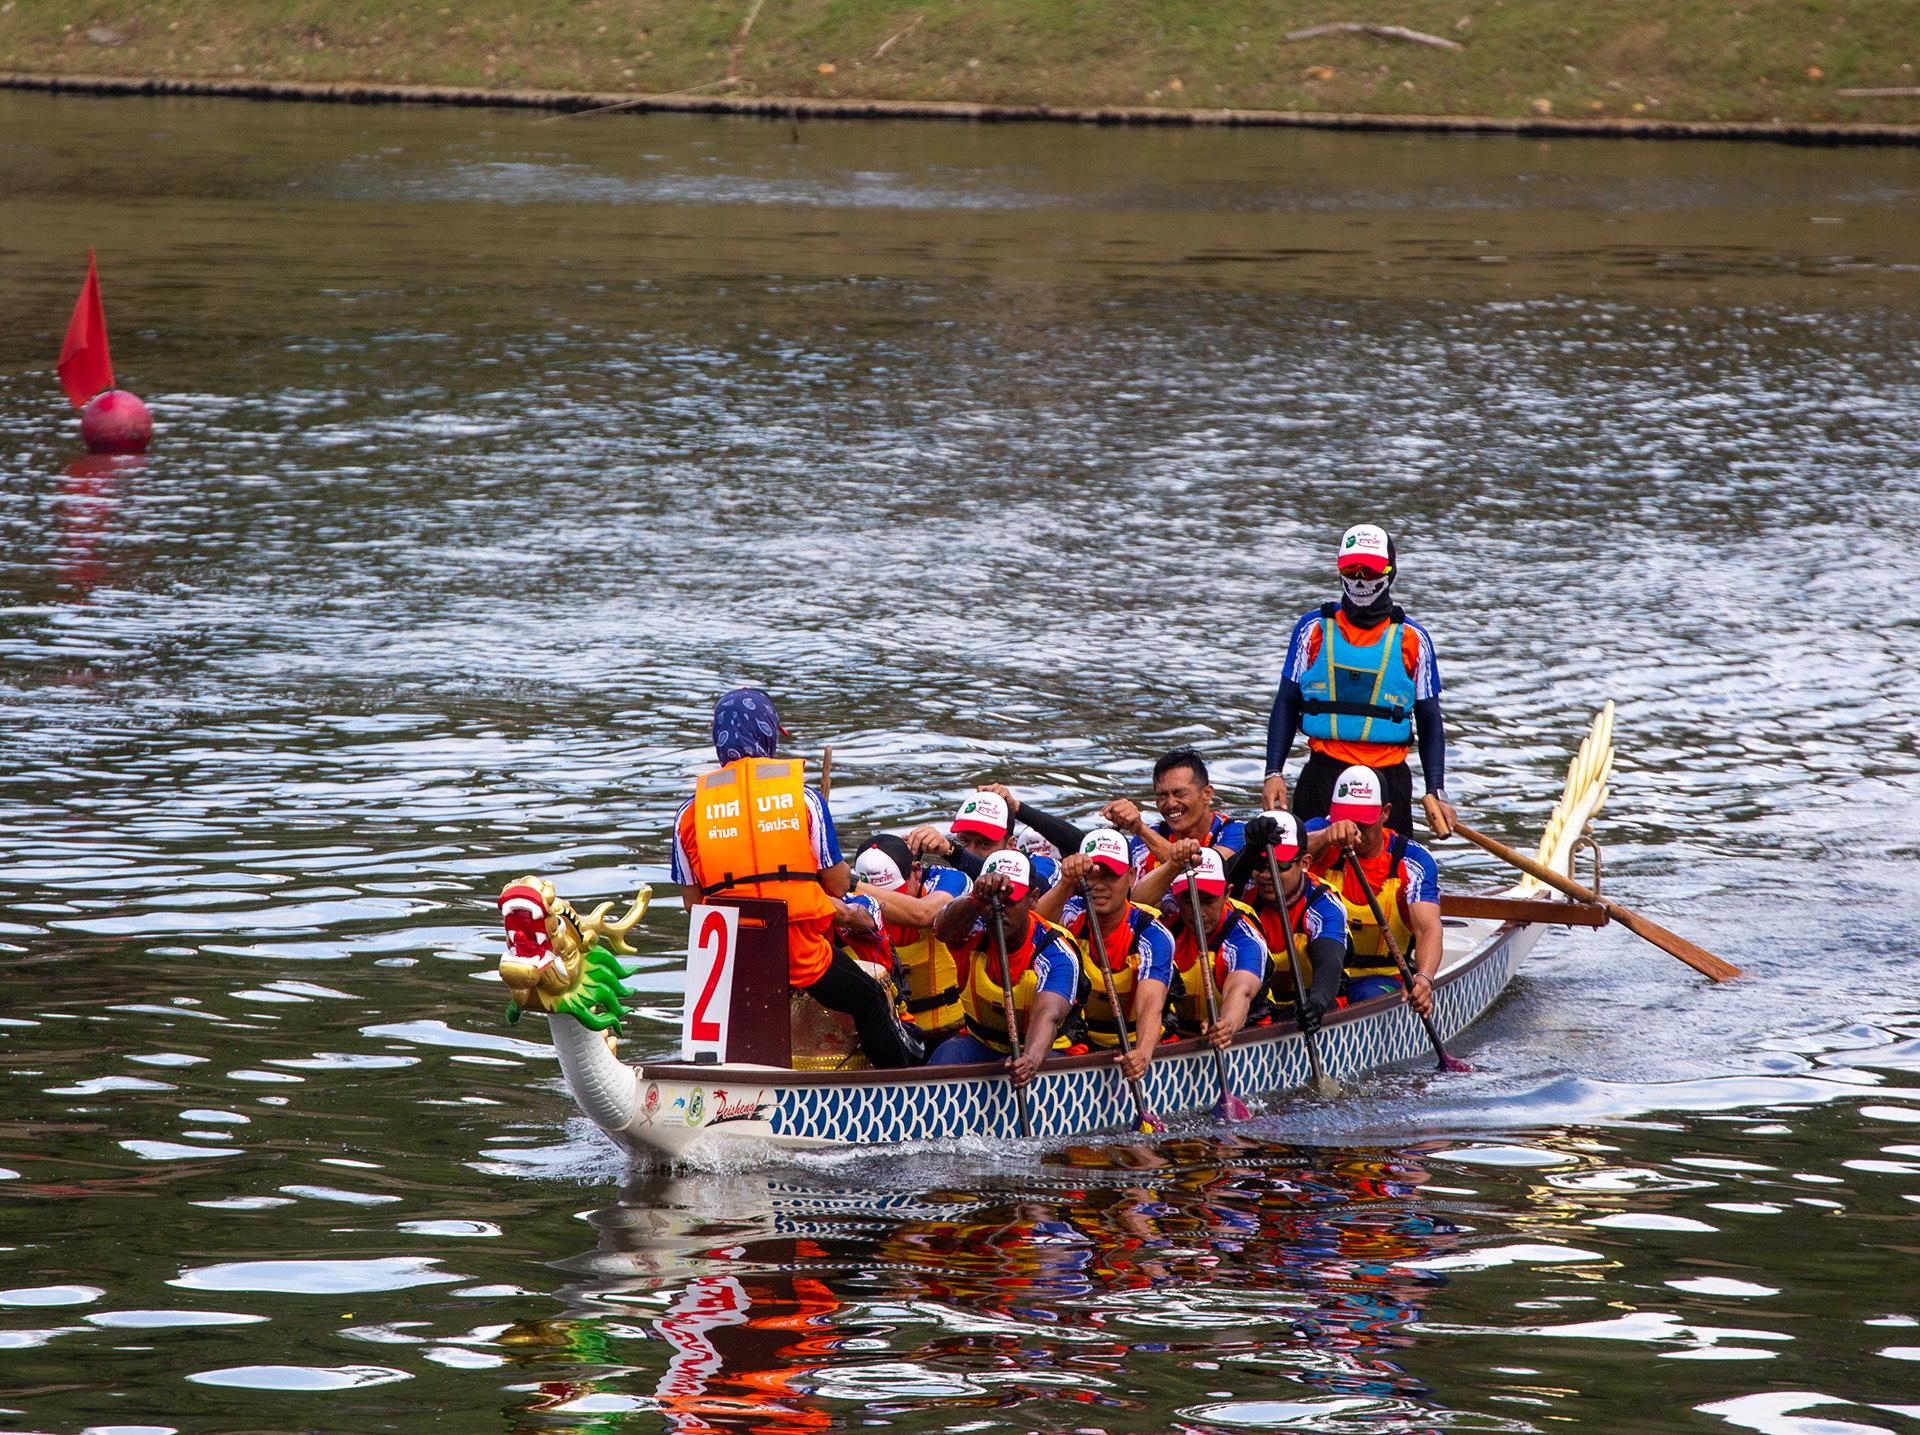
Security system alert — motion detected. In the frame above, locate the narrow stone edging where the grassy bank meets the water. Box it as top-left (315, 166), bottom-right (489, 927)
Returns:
top-left (0, 71), bottom-right (1920, 146)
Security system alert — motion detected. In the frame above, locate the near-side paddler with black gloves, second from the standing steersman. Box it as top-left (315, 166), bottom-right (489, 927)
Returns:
top-left (1227, 813), bottom-right (1365, 1032)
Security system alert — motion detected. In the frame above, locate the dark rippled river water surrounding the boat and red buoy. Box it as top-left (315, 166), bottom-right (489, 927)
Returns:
top-left (0, 96), bottom-right (1920, 1435)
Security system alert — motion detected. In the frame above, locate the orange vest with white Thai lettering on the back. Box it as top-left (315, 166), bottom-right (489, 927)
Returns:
top-left (687, 757), bottom-right (835, 987)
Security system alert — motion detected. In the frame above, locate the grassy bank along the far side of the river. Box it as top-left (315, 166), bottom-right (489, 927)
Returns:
top-left (0, 0), bottom-right (1920, 123)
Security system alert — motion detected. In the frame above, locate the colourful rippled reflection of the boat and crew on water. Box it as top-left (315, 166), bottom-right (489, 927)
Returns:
top-left (501, 1135), bottom-right (1459, 1435)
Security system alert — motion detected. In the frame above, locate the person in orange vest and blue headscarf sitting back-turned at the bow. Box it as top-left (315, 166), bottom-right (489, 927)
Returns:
top-left (672, 688), bottom-right (924, 1068)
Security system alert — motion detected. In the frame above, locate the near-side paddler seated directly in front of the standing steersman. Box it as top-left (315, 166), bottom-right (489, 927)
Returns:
top-left (1306, 766), bottom-right (1444, 1016)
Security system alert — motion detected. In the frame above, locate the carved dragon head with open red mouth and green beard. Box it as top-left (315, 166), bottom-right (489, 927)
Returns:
top-left (499, 876), bottom-right (653, 1032)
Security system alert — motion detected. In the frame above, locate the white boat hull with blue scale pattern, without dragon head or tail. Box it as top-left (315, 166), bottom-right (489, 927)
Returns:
top-left (555, 922), bottom-right (1542, 1158)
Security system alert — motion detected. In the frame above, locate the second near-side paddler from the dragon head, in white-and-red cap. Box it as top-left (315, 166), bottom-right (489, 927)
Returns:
top-left (1033, 828), bottom-right (1173, 1082)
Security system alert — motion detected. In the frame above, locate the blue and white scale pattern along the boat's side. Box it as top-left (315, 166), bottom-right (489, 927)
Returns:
top-left (772, 928), bottom-right (1538, 1145)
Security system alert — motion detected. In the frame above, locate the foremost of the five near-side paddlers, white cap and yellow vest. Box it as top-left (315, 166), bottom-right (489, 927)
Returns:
top-left (927, 851), bottom-right (1085, 1085)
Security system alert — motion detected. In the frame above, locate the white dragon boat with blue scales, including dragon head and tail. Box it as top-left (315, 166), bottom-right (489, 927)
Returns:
top-left (499, 701), bottom-right (1613, 1160)
